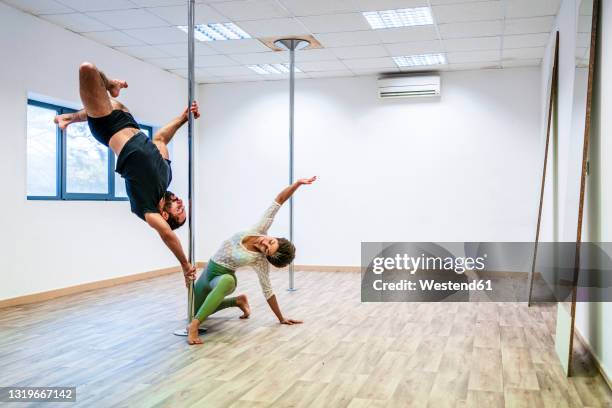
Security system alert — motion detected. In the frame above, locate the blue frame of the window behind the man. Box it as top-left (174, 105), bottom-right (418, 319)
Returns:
top-left (26, 98), bottom-right (153, 201)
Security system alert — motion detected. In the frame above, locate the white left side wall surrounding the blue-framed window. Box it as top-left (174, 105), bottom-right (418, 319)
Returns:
top-left (0, 3), bottom-right (187, 299)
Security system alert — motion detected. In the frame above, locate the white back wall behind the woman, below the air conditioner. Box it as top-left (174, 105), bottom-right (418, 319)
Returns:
top-left (198, 68), bottom-right (541, 265)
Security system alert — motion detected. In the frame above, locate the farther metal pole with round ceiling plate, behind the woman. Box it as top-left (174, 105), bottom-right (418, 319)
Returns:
top-left (274, 38), bottom-right (310, 291)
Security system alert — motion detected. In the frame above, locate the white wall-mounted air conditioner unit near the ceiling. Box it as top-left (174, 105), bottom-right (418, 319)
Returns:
top-left (378, 75), bottom-right (440, 98)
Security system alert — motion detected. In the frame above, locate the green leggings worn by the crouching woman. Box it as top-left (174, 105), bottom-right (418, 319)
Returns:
top-left (193, 261), bottom-right (237, 322)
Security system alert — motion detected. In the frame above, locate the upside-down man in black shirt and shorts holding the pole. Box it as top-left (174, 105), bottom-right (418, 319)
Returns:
top-left (55, 62), bottom-right (200, 285)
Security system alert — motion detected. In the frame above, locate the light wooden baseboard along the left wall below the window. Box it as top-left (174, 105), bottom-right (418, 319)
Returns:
top-left (0, 262), bottom-right (206, 309)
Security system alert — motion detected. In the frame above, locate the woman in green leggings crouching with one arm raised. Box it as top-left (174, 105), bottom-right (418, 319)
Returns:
top-left (187, 177), bottom-right (317, 344)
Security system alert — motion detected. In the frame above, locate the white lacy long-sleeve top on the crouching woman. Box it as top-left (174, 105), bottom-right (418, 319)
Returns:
top-left (211, 201), bottom-right (281, 299)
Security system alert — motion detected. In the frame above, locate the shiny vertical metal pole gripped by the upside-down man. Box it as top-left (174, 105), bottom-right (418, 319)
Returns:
top-left (187, 0), bottom-right (196, 322)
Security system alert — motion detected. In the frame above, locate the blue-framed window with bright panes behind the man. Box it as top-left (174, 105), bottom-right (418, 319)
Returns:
top-left (27, 100), bottom-right (153, 200)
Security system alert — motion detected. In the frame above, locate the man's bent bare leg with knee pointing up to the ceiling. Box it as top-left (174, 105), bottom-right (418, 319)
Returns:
top-left (79, 62), bottom-right (127, 118)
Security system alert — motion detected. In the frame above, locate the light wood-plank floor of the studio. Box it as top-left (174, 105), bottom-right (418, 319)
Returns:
top-left (0, 271), bottom-right (612, 408)
